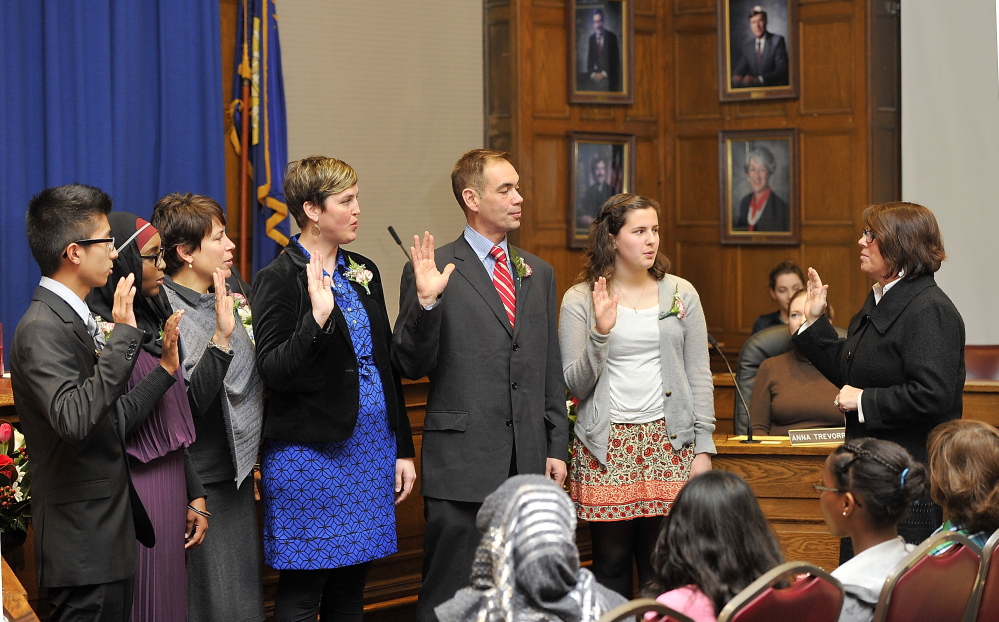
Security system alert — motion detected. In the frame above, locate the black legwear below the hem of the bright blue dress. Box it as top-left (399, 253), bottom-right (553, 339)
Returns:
top-left (274, 562), bottom-right (371, 622)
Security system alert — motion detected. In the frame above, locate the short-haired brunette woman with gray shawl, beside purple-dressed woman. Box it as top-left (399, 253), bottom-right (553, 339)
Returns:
top-left (153, 193), bottom-right (264, 622)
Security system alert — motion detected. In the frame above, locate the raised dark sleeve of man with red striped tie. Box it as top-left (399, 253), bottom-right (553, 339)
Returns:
top-left (392, 263), bottom-right (444, 380)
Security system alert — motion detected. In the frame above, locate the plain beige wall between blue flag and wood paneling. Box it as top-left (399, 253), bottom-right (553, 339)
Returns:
top-left (278, 0), bottom-right (483, 320)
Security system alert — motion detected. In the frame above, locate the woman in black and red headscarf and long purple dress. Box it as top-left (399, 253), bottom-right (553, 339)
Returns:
top-left (87, 212), bottom-right (208, 622)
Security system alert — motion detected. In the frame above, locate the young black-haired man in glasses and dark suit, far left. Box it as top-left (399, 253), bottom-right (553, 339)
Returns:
top-left (10, 184), bottom-right (180, 621)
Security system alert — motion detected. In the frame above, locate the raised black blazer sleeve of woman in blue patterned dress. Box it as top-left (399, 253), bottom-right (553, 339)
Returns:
top-left (253, 269), bottom-right (339, 391)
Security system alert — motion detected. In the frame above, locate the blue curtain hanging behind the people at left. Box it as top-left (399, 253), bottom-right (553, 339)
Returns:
top-left (0, 0), bottom-right (225, 358)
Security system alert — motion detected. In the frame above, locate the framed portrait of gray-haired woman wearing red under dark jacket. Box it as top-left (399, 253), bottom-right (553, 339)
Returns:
top-left (718, 129), bottom-right (801, 244)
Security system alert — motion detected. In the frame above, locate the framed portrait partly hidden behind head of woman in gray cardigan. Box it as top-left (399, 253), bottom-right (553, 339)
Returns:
top-left (568, 133), bottom-right (635, 248)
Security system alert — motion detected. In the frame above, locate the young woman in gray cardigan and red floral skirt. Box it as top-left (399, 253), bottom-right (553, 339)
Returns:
top-left (559, 194), bottom-right (715, 596)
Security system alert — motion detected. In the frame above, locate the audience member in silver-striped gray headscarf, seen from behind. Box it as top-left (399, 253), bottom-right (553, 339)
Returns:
top-left (436, 475), bottom-right (625, 622)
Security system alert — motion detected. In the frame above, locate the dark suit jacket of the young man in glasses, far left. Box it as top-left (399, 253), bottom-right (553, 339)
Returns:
top-left (10, 287), bottom-right (174, 587)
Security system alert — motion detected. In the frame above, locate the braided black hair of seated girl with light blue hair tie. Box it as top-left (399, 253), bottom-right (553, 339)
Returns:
top-left (830, 438), bottom-right (929, 529)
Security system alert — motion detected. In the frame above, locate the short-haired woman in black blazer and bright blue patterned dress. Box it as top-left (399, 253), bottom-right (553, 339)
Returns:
top-left (253, 156), bottom-right (416, 622)
